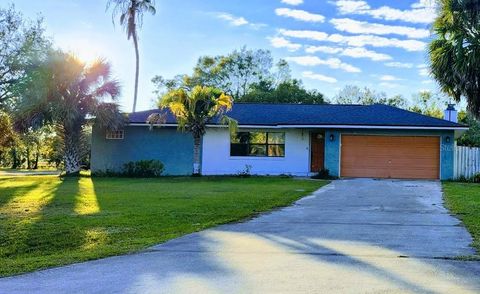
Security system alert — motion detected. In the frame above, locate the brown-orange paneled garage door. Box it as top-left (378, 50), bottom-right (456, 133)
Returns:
top-left (340, 135), bottom-right (440, 179)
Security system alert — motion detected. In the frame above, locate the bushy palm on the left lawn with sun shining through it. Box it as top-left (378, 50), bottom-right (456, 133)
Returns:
top-left (17, 51), bottom-right (124, 174)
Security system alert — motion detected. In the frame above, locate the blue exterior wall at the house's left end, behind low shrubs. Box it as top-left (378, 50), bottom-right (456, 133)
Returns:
top-left (91, 126), bottom-right (193, 175)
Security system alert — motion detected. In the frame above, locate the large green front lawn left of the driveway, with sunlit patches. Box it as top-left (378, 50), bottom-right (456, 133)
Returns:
top-left (0, 176), bottom-right (327, 276)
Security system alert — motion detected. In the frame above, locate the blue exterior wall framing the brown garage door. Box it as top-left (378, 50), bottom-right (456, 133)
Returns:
top-left (324, 129), bottom-right (454, 180)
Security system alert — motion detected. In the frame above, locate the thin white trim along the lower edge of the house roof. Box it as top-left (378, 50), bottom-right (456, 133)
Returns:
top-left (129, 123), bottom-right (469, 131)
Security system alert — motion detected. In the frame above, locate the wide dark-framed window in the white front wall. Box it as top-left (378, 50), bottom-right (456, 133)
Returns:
top-left (230, 132), bottom-right (285, 157)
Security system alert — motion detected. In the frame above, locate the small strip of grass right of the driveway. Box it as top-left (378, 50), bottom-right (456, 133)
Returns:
top-left (443, 182), bottom-right (480, 255)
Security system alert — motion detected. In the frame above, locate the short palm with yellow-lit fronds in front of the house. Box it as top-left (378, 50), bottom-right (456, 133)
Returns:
top-left (148, 86), bottom-right (237, 175)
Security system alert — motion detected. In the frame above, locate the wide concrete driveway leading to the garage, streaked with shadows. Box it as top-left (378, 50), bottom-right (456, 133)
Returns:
top-left (0, 179), bottom-right (480, 293)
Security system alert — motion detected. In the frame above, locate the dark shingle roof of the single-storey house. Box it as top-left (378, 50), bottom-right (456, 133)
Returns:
top-left (129, 103), bottom-right (465, 128)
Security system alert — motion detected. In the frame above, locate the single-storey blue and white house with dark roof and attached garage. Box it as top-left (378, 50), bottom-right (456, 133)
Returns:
top-left (91, 103), bottom-right (467, 179)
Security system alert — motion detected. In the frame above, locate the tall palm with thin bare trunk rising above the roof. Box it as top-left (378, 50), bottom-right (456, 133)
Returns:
top-left (107, 0), bottom-right (156, 112)
